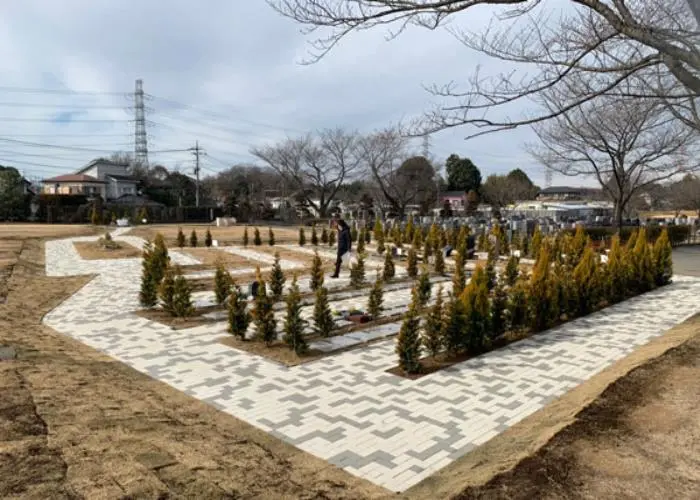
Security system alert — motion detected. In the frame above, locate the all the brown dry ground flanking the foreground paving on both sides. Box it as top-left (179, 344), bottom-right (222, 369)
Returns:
top-left (0, 226), bottom-right (700, 500)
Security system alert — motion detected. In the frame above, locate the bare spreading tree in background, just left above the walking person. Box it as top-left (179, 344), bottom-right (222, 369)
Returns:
top-left (251, 129), bottom-right (361, 217)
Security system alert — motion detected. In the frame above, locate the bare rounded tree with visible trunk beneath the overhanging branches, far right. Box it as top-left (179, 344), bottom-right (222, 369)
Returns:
top-left (529, 89), bottom-right (698, 227)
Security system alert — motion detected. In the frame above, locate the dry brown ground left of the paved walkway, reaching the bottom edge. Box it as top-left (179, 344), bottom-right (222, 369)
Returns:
top-left (0, 235), bottom-right (389, 500)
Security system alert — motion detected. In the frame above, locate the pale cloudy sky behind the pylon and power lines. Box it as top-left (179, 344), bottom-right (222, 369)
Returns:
top-left (0, 0), bottom-right (584, 185)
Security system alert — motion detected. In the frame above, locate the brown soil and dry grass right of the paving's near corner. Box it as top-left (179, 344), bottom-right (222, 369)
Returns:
top-left (402, 315), bottom-right (700, 500)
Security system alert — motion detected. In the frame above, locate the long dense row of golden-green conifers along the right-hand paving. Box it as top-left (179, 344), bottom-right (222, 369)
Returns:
top-left (396, 228), bottom-right (672, 373)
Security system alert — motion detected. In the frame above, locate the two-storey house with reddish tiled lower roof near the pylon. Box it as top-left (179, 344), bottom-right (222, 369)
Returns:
top-left (42, 158), bottom-right (138, 200)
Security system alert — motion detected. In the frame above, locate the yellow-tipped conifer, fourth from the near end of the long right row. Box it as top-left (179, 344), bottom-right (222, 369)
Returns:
top-left (460, 266), bottom-right (490, 354)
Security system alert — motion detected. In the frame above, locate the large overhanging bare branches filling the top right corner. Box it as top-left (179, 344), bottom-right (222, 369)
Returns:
top-left (267, 0), bottom-right (700, 137)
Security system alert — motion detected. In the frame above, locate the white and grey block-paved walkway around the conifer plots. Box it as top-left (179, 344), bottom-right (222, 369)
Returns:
top-left (44, 229), bottom-right (700, 491)
